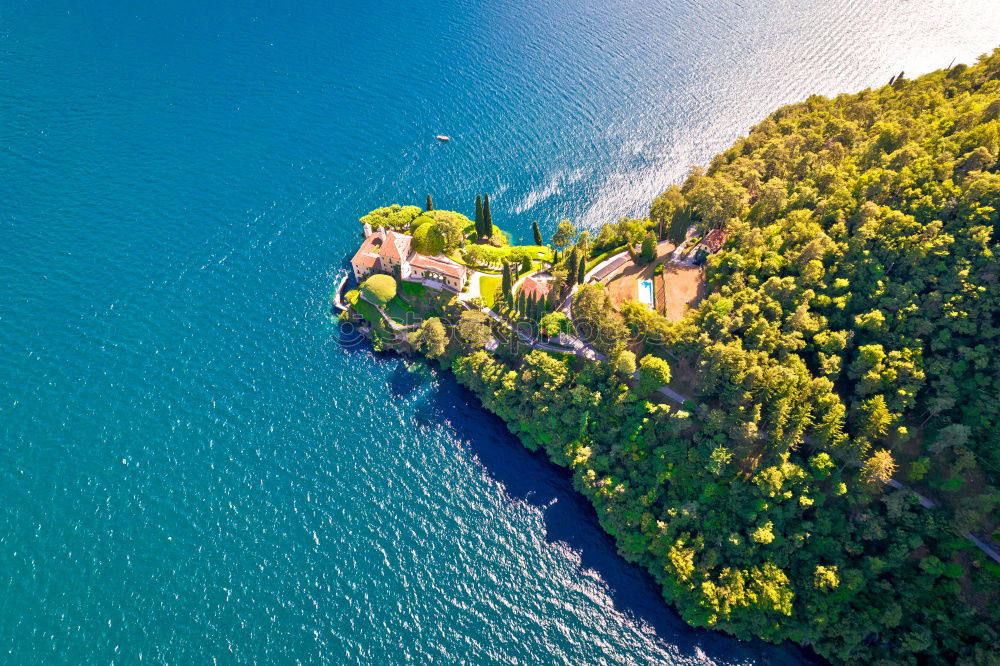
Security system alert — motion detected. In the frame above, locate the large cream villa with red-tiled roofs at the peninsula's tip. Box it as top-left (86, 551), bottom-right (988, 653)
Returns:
top-left (351, 224), bottom-right (467, 291)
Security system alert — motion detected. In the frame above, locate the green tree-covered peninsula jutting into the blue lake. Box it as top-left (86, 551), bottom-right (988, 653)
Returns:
top-left (343, 49), bottom-right (1000, 665)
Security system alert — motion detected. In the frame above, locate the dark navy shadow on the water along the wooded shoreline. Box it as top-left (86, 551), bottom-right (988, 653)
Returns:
top-left (340, 328), bottom-right (825, 664)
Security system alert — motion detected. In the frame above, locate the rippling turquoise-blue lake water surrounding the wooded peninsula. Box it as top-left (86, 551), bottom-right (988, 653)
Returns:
top-left (0, 0), bottom-right (1000, 664)
